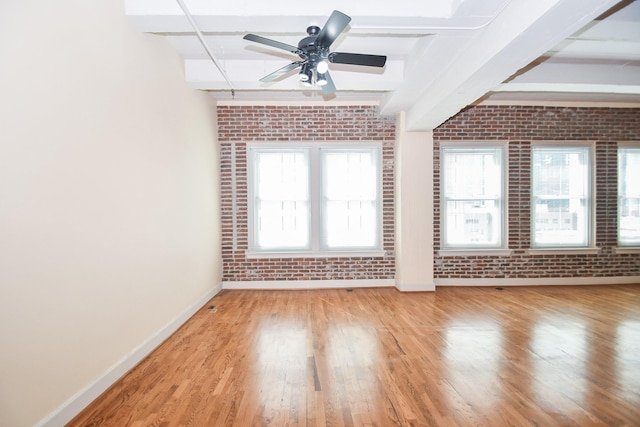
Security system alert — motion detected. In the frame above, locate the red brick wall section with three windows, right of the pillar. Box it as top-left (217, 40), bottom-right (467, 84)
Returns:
top-left (434, 106), bottom-right (640, 280)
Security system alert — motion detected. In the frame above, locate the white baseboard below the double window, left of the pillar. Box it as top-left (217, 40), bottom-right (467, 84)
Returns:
top-left (222, 279), bottom-right (395, 290)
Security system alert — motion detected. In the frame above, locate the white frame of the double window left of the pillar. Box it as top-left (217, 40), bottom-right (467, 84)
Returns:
top-left (246, 141), bottom-right (385, 258)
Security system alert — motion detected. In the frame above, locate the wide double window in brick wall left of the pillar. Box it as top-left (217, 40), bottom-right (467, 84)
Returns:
top-left (248, 144), bottom-right (382, 253)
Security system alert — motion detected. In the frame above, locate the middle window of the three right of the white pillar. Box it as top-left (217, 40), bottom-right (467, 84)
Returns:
top-left (531, 145), bottom-right (592, 248)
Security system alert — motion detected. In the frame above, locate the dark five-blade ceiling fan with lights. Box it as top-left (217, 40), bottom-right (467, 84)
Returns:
top-left (243, 10), bottom-right (387, 95)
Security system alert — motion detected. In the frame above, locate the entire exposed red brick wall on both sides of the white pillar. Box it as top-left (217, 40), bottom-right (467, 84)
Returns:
top-left (218, 106), bottom-right (640, 281)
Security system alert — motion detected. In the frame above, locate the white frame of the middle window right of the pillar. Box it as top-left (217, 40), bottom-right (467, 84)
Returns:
top-left (530, 141), bottom-right (596, 251)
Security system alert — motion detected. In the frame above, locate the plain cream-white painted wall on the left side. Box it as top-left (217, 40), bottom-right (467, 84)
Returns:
top-left (0, 0), bottom-right (221, 427)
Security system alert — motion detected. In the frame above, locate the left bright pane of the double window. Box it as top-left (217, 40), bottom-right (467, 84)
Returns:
top-left (254, 150), bottom-right (310, 249)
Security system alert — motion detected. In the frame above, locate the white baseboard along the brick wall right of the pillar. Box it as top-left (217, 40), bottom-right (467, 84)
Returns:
top-left (435, 276), bottom-right (640, 287)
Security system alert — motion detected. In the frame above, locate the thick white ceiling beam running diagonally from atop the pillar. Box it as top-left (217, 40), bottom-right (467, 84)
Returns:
top-left (381, 0), bottom-right (618, 131)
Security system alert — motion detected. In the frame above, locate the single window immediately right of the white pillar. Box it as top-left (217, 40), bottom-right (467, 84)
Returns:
top-left (442, 146), bottom-right (505, 249)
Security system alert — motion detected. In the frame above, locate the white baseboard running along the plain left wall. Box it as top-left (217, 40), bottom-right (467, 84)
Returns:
top-left (36, 284), bottom-right (222, 427)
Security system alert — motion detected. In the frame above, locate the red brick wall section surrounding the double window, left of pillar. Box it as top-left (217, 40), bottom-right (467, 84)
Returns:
top-left (218, 106), bottom-right (396, 281)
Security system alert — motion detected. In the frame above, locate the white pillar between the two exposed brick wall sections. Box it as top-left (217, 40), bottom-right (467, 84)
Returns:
top-left (395, 112), bottom-right (436, 292)
